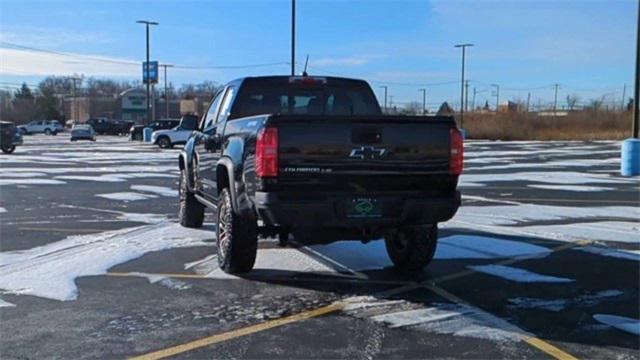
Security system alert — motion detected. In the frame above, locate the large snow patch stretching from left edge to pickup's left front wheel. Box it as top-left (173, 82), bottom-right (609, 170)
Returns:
top-left (0, 222), bottom-right (211, 301)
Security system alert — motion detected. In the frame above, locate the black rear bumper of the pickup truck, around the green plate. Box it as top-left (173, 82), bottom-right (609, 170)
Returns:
top-left (253, 191), bottom-right (460, 228)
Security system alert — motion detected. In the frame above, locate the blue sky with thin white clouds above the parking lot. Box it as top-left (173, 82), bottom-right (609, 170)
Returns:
top-left (0, 0), bottom-right (638, 109)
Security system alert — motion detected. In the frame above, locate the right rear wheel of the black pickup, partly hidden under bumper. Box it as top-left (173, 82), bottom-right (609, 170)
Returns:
top-left (384, 225), bottom-right (438, 272)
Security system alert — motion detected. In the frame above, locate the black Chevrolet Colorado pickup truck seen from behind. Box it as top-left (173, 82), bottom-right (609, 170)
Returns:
top-left (179, 76), bottom-right (463, 273)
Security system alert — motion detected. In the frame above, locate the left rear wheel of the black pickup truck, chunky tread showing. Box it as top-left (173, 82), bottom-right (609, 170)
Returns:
top-left (216, 188), bottom-right (258, 274)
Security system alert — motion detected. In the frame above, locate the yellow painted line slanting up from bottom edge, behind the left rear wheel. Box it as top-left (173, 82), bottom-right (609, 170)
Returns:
top-left (131, 303), bottom-right (344, 360)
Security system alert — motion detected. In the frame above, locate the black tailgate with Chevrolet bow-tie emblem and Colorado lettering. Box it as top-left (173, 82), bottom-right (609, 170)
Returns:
top-left (270, 116), bottom-right (455, 191)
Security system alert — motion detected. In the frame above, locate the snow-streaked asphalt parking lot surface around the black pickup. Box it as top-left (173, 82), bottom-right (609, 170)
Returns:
top-left (0, 134), bottom-right (640, 359)
